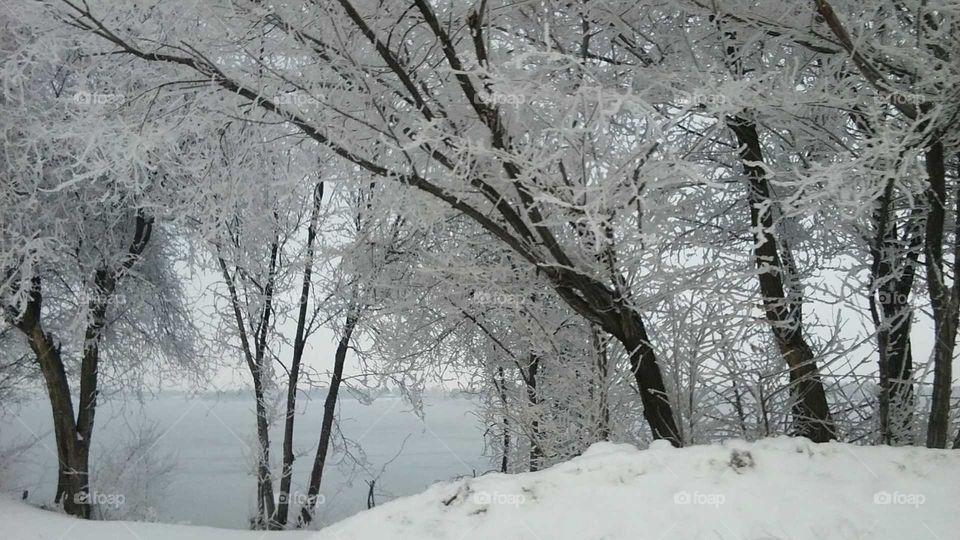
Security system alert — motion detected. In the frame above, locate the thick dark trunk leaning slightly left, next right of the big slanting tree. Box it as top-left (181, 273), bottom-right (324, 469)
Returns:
top-left (728, 117), bottom-right (836, 442)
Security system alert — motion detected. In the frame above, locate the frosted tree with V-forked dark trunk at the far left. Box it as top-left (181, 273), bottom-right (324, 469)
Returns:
top-left (0, 8), bottom-right (197, 517)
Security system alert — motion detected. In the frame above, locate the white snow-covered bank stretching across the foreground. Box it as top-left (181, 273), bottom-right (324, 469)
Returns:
top-left (0, 438), bottom-right (960, 540)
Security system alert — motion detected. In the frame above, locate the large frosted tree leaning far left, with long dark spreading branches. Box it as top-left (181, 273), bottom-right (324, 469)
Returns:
top-left (52, 2), bottom-right (696, 444)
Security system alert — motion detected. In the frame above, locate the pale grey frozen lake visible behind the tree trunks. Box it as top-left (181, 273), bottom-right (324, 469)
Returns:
top-left (0, 394), bottom-right (492, 528)
